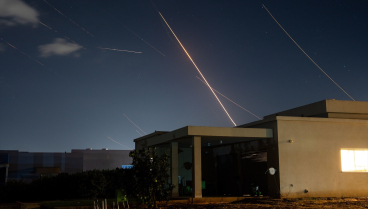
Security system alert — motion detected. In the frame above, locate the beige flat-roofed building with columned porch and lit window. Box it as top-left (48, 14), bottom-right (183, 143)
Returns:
top-left (134, 100), bottom-right (368, 198)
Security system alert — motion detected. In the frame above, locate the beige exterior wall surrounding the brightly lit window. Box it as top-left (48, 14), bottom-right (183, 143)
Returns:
top-left (277, 116), bottom-right (368, 198)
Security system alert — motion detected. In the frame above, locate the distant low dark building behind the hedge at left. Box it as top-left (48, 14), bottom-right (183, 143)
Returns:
top-left (0, 148), bottom-right (132, 183)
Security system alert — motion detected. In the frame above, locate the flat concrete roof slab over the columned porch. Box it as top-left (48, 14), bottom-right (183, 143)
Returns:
top-left (134, 126), bottom-right (273, 146)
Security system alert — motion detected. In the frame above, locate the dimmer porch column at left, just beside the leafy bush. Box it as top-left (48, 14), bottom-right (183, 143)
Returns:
top-left (170, 142), bottom-right (179, 197)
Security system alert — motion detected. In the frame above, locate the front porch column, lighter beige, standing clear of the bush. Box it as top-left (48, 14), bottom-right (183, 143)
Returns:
top-left (192, 136), bottom-right (202, 198)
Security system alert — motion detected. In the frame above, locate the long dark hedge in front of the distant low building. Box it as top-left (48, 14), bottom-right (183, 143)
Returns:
top-left (0, 168), bottom-right (133, 202)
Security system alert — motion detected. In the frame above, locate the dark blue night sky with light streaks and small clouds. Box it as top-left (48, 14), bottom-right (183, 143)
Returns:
top-left (0, 0), bottom-right (368, 152)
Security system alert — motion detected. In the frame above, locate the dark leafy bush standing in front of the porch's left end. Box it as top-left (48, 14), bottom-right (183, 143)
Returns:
top-left (129, 148), bottom-right (174, 208)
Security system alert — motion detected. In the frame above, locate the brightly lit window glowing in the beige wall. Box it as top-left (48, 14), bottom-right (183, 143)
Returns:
top-left (341, 149), bottom-right (368, 172)
